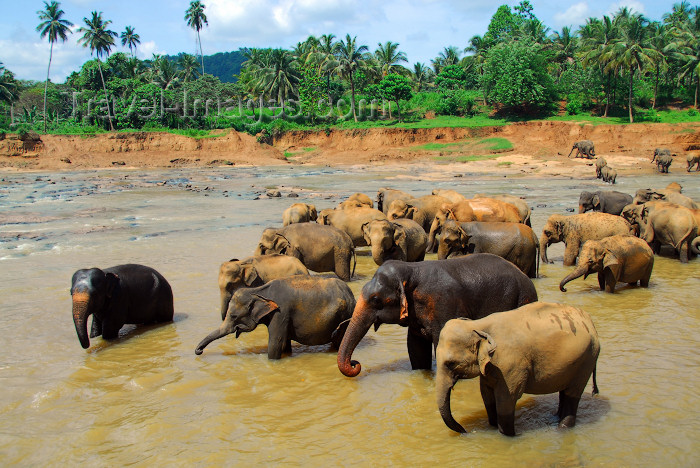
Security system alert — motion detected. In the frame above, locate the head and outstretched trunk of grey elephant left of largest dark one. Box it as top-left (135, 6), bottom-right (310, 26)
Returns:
top-left (194, 288), bottom-right (279, 355)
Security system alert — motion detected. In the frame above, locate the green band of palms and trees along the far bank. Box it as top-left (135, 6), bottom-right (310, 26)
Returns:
top-left (0, 0), bottom-right (700, 133)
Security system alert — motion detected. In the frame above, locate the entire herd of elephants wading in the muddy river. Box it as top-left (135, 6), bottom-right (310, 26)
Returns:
top-left (71, 143), bottom-right (700, 435)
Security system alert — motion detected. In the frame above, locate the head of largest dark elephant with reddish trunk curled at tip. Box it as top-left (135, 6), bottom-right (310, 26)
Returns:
top-left (338, 261), bottom-right (408, 377)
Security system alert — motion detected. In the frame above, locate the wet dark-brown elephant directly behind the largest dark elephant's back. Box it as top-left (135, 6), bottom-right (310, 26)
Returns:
top-left (438, 219), bottom-right (539, 278)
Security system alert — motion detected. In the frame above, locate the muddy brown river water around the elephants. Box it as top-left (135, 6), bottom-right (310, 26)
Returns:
top-left (0, 165), bottom-right (700, 466)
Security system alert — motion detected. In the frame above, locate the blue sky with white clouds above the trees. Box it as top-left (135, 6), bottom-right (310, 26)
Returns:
top-left (0, 0), bottom-right (674, 82)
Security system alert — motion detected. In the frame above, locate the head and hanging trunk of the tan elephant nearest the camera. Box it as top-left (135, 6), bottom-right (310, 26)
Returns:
top-left (435, 319), bottom-right (496, 433)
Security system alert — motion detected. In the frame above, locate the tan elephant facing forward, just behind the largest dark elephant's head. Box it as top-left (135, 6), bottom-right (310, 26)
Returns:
top-left (362, 218), bottom-right (428, 265)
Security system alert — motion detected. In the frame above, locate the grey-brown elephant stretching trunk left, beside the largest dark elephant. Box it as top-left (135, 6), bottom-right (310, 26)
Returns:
top-left (195, 276), bottom-right (355, 359)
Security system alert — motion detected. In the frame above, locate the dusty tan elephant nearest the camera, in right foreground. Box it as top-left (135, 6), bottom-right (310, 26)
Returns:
top-left (435, 302), bottom-right (600, 436)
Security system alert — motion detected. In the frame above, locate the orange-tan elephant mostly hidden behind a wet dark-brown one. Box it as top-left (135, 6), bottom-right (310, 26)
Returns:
top-left (428, 198), bottom-right (521, 251)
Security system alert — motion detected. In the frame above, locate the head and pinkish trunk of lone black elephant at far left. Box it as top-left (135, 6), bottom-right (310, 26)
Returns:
top-left (70, 268), bottom-right (120, 349)
